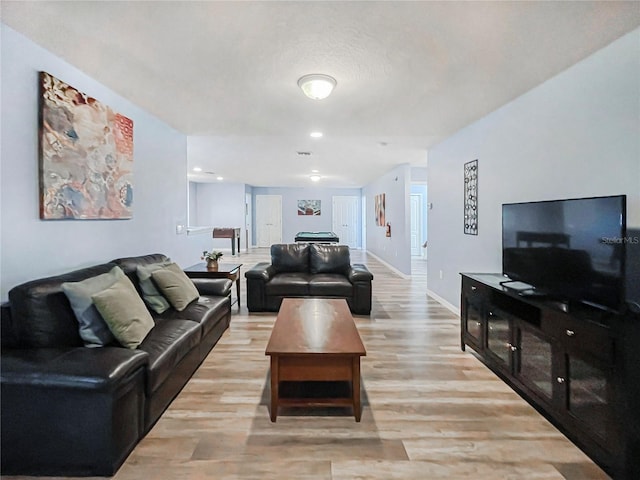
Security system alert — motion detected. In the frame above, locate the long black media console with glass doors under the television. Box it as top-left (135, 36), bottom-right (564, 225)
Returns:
top-left (460, 273), bottom-right (640, 479)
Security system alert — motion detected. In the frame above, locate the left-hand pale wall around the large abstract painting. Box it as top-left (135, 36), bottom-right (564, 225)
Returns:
top-left (0, 25), bottom-right (192, 301)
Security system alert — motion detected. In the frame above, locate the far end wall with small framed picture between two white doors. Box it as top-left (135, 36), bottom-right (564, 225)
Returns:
top-left (253, 187), bottom-right (362, 246)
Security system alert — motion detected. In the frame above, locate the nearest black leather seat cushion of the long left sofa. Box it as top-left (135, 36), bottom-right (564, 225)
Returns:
top-left (138, 319), bottom-right (201, 395)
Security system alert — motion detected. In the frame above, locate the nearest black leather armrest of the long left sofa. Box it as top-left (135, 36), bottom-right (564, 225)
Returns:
top-left (0, 347), bottom-right (149, 477)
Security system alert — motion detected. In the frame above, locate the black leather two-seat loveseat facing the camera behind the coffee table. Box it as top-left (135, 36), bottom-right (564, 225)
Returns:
top-left (245, 243), bottom-right (373, 315)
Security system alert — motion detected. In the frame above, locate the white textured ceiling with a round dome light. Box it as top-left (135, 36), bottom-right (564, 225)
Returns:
top-left (1, 0), bottom-right (640, 187)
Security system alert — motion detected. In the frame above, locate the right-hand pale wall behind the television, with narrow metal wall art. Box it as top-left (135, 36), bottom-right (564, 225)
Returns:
top-left (428, 29), bottom-right (640, 305)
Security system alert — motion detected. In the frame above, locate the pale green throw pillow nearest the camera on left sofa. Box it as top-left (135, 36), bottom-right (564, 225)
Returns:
top-left (91, 277), bottom-right (155, 349)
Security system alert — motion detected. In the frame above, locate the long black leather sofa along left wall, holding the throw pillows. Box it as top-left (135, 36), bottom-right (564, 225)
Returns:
top-left (0, 254), bottom-right (231, 476)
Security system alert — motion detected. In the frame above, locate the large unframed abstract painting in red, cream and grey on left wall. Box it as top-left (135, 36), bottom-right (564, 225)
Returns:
top-left (39, 72), bottom-right (133, 220)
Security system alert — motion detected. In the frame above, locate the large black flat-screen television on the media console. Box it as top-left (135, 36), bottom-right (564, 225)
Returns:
top-left (502, 195), bottom-right (626, 311)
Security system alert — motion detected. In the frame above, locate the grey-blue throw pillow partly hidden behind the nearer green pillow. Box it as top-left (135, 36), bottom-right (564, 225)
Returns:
top-left (62, 267), bottom-right (125, 347)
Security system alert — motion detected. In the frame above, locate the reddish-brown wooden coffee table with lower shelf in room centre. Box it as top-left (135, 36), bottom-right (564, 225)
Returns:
top-left (265, 298), bottom-right (367, 422)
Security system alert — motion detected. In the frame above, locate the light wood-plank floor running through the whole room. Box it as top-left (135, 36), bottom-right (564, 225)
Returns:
top-left (7, 249), bottom-right (609, 480)
